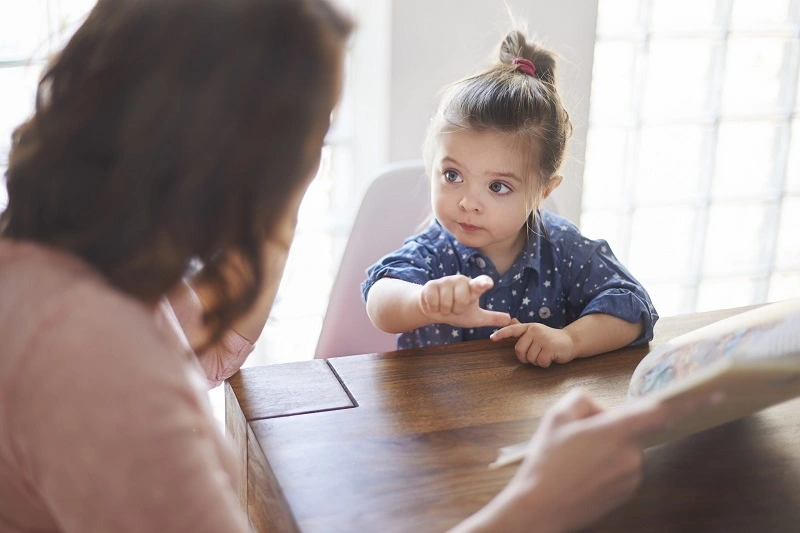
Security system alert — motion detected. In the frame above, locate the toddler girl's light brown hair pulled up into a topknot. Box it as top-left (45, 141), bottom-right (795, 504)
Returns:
top-left (423, 30), bottom-right (572, 207)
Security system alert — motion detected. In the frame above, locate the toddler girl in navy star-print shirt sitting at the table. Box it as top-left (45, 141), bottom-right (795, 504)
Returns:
top-left (362, 31), bottom-right (658, 367)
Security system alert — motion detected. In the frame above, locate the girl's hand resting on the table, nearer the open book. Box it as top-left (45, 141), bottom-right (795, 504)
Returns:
top-left (489, 322), bottom-right (576, 368)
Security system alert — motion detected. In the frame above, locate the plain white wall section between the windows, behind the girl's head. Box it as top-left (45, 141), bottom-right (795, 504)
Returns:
top-left (388, 0), bottom-right (597, 222)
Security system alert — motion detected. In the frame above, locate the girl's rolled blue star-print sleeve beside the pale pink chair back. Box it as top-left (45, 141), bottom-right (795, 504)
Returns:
top-left (361, 235), bottom-right (446, 301)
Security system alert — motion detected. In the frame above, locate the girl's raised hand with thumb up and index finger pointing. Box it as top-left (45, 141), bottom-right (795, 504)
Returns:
top-left (420, 275), bottom-right (511, 328)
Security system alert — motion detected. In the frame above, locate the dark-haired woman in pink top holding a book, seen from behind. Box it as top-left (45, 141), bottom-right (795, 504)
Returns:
top-left (0, 0), bottom-right (664, 532)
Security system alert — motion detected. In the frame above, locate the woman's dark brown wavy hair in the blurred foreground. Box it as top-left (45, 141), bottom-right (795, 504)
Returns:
top-left (0, 0), bottom-right (351, 339)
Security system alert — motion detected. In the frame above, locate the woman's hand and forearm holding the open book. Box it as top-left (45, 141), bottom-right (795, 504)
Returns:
top-left (453, 391), bottom-right (670, 533)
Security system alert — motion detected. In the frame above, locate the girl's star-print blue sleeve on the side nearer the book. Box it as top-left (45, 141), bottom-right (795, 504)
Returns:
top-left (567, 240), bottom-right (658, 345)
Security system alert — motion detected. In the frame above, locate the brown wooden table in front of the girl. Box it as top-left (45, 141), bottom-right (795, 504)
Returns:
top-left (225, 309), bottom-right (800, 533)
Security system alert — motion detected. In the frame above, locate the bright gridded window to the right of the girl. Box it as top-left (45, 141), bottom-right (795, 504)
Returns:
top-left (581, 0), bottom-right (800, 316)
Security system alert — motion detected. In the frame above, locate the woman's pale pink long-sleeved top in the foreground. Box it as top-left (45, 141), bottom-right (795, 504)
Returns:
top-left (0, 240), bottom-right (253, 533)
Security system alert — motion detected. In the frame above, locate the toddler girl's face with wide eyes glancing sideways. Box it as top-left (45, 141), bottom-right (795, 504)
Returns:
top-left (431, 129), bottom-right (538, 261)
